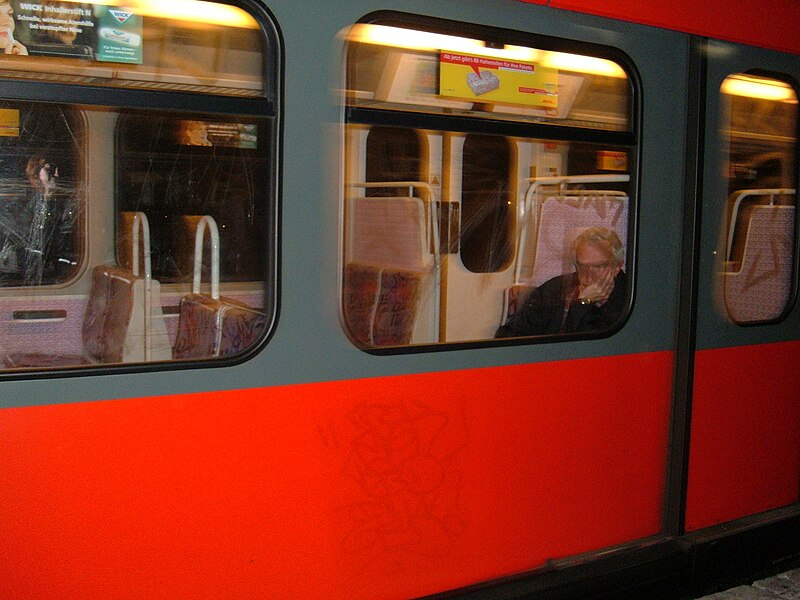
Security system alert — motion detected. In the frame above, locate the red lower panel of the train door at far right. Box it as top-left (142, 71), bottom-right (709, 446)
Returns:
top-left (686, 342), bottom-right (800, 531)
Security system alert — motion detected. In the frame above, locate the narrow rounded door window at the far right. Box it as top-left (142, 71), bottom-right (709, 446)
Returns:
top-left (720, 73), bottom-right (797, 324)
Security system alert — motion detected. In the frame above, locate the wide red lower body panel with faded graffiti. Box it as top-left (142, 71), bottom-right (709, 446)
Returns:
top-left (0, 352), bottom-right (673, 600)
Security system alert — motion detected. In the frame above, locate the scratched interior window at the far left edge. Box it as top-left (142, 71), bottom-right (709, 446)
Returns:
top-left (0, 100), bottom-right (86, 287)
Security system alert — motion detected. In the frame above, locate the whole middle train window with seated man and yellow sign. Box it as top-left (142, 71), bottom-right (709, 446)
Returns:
top-left (341, 15), bottom-right (638, 350)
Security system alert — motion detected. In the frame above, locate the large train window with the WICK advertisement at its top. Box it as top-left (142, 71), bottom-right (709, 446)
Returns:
top-left (0, 0), bottom-right (281, 370)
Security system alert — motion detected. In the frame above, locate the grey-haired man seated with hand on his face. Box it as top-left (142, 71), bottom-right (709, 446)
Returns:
top-left (495, 227), bottom-right (626, 338)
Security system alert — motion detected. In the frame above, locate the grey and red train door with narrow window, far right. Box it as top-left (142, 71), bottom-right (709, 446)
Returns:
top-left (686, 42), bottom-right (800, 531)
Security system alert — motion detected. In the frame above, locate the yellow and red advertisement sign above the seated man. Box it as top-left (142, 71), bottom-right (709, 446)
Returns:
top-left (439, 52), bottom-right (558, 109)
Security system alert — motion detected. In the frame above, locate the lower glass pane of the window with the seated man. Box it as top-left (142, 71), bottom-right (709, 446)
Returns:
top-left (342, 126), bottom-right (630, 348)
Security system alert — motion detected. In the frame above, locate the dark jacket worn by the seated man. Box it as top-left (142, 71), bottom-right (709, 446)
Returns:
top-left (495, 271), bottom-right (627, 338)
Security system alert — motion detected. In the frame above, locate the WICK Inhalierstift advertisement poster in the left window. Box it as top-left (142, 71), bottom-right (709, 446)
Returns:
top-left (0, 0), bottom-right (142, 64)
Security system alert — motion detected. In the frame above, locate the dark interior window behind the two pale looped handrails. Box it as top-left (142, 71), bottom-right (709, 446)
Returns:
top-left (116, 112), bottom-right (271, 283)
